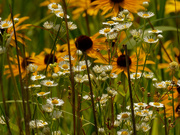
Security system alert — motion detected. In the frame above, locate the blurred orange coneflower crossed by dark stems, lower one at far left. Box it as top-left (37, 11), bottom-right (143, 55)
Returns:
top-left (4, 53), bottom-right (35, 78)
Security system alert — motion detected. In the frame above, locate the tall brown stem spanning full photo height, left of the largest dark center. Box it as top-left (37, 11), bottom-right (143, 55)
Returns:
top-left (62, 0), bottom-right (76, 135)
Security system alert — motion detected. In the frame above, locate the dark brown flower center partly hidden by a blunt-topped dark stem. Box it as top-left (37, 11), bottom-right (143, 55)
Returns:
top-left (117, 54), bottom-right (132, 67)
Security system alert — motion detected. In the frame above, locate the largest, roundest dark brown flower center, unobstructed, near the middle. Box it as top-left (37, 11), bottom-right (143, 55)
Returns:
top-left (75, 35), bottom-right (93, 51)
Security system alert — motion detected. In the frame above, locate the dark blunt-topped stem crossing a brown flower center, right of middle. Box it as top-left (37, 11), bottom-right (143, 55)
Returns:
top-left (124, 45), bottom-right (136, 135)
